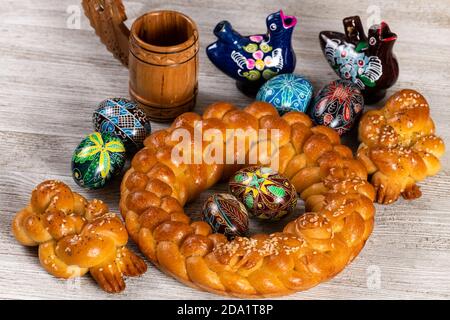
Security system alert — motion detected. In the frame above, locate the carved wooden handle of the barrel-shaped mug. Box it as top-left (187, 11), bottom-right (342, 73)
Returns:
top-left (83, 0), bottom-right (130, 67)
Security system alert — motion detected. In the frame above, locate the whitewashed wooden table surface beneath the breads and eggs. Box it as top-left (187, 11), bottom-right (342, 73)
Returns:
top-left (0, 0), bottom-right (450, 299)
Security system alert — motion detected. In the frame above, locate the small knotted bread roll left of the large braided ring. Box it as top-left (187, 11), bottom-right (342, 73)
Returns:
top-left (12, 180), bottom-right (147, 293)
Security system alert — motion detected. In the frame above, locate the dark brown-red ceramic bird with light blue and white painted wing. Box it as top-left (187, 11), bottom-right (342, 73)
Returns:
top-left (319, 16), bottom-right (399, 103)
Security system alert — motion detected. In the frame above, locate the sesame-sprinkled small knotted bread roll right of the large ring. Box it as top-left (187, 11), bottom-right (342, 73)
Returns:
top-left (357, 89), bottom-right (445, 204)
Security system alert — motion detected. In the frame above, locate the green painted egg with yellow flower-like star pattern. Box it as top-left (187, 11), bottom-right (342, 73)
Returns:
top-left (72, 132), bottom-right (126, 189)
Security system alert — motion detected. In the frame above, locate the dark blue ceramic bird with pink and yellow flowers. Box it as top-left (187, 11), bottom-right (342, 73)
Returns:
top-left (206, 10), bottom-right (297, 95)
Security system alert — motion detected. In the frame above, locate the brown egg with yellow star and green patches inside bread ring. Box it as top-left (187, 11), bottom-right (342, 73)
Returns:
top-left (229, 166), bottom-right (297, 220)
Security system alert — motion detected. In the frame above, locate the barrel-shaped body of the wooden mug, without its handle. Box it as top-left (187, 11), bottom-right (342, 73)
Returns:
top-left (128, 11), bottom-right (199, 121)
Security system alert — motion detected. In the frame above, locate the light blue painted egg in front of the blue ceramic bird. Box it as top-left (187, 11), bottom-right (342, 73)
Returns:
top-left (256, 73), bottom-right (313, 115)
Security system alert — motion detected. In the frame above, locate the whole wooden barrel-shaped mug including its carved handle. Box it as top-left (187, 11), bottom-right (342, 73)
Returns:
top-left (83, 0), bottom-right (199, 122)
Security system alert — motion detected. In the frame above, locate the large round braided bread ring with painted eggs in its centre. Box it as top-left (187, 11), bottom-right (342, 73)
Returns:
top-left (120, 102), bottom-right (375, 298)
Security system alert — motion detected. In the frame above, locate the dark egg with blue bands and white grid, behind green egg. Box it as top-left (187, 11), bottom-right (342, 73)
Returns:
top-left (93, 98), bottom-right (151, 154)
